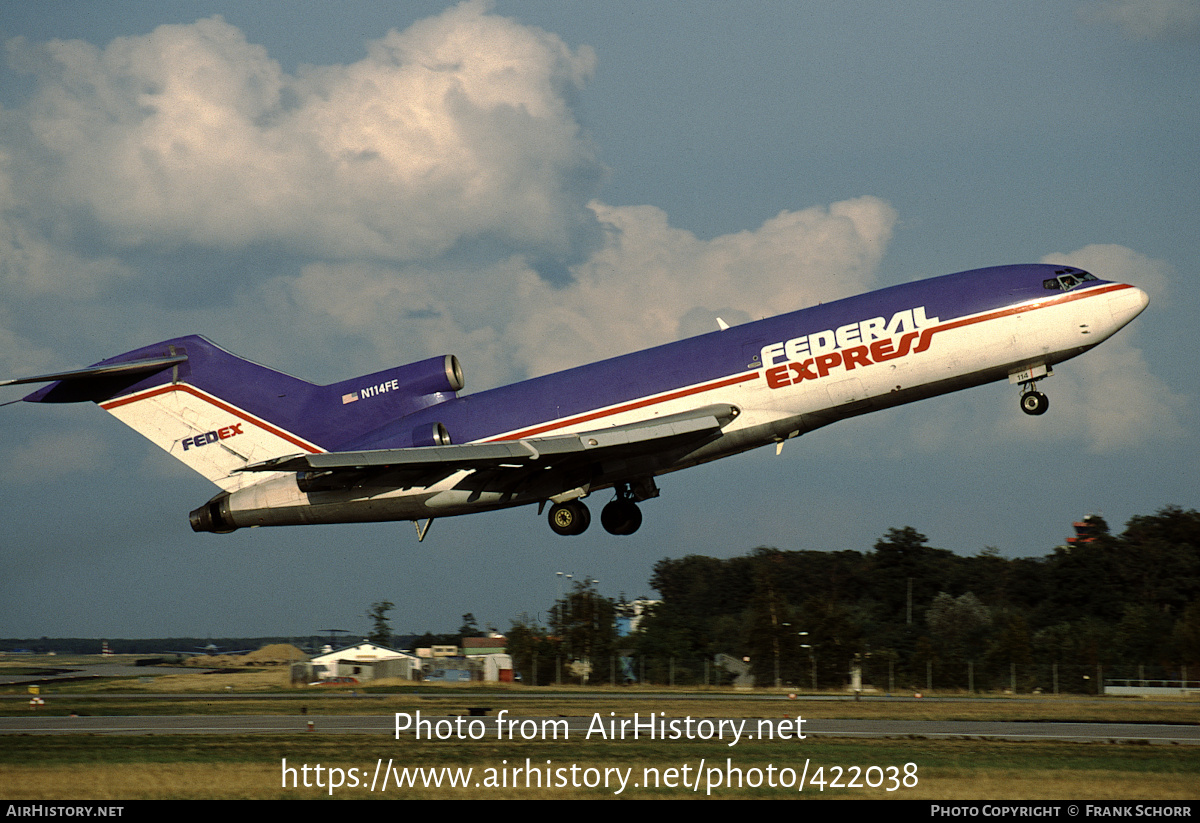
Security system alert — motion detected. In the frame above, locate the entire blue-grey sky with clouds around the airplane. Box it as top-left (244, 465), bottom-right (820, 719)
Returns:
top-left (0, 0), bottom-right (1200, 637)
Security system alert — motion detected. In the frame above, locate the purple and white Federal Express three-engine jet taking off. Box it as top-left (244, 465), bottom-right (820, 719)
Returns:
top-left (0, 264), bottom-right (1148, 541)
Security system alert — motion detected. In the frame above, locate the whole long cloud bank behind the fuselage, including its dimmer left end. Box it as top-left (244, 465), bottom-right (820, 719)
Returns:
top-left (290, 197), bottom-right (895, 388)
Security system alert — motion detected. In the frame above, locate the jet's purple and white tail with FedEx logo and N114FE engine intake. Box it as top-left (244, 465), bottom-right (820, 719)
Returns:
top-left (10, 336), bottom-right (462, 491)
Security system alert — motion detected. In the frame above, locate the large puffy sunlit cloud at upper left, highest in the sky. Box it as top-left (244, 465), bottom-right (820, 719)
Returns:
top-left (1, 2), bottom-right (600, 267)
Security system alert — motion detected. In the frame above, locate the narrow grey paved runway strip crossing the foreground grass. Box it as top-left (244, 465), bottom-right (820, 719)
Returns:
top-left (0, 714), bottom-right (1200, 745)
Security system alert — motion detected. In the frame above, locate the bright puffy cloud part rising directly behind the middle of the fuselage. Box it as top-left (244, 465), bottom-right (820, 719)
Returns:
top-left (496, 197), bottom-right (895, 373)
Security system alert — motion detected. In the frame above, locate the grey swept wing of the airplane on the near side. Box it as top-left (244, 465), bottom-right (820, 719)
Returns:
top-left (236, 404), bottom-right (738, 488)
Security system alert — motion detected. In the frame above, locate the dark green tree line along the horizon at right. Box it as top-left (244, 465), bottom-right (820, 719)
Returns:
top-left (509, 506), bottom-right (1200, 692)
